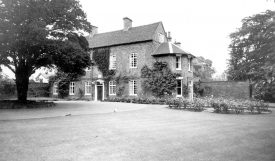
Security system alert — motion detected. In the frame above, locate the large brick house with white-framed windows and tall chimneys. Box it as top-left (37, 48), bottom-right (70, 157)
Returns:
top-left (53, 17), bottom-right (194, 101)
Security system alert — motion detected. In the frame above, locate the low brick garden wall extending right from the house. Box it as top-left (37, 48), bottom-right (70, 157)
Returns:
top-left (200, 81), bottom-right (250, 99)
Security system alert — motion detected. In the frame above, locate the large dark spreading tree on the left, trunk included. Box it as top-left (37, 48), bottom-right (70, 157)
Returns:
top-left (0, 0), bottom-right (91, 101)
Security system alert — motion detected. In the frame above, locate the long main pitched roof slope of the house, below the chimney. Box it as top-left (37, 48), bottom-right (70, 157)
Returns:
top-left (87, 22), bottom-right (162, 48)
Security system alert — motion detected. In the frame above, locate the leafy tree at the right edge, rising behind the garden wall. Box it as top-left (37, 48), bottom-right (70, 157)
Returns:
top-left (228, 10), bottom-right (275, 100)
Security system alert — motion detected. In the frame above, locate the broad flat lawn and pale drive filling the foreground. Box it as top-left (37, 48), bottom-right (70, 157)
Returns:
top-left (0, 103), bottom-right (275, 161)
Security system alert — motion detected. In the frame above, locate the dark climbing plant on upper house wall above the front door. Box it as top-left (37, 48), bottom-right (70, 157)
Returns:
top-left (93, 48), bottom-right (115, 79)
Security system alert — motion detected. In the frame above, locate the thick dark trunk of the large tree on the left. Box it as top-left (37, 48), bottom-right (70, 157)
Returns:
top-left (15, 70), bottom-right (29, 102)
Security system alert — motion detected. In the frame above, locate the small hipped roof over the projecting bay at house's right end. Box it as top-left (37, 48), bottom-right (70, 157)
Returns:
top-left (152, 42), bottom-right (194, 57)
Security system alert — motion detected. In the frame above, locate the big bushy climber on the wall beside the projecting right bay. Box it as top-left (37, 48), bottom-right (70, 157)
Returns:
top-left (141, 62), bottom-right (179, 97)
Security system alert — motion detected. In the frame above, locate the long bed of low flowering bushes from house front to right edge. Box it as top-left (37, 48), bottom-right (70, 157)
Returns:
top-left (106, 97), bottom-right (271, 114)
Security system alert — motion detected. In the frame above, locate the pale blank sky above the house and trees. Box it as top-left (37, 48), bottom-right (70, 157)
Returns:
top-left (1, 0), bottom-right (275, 78)
